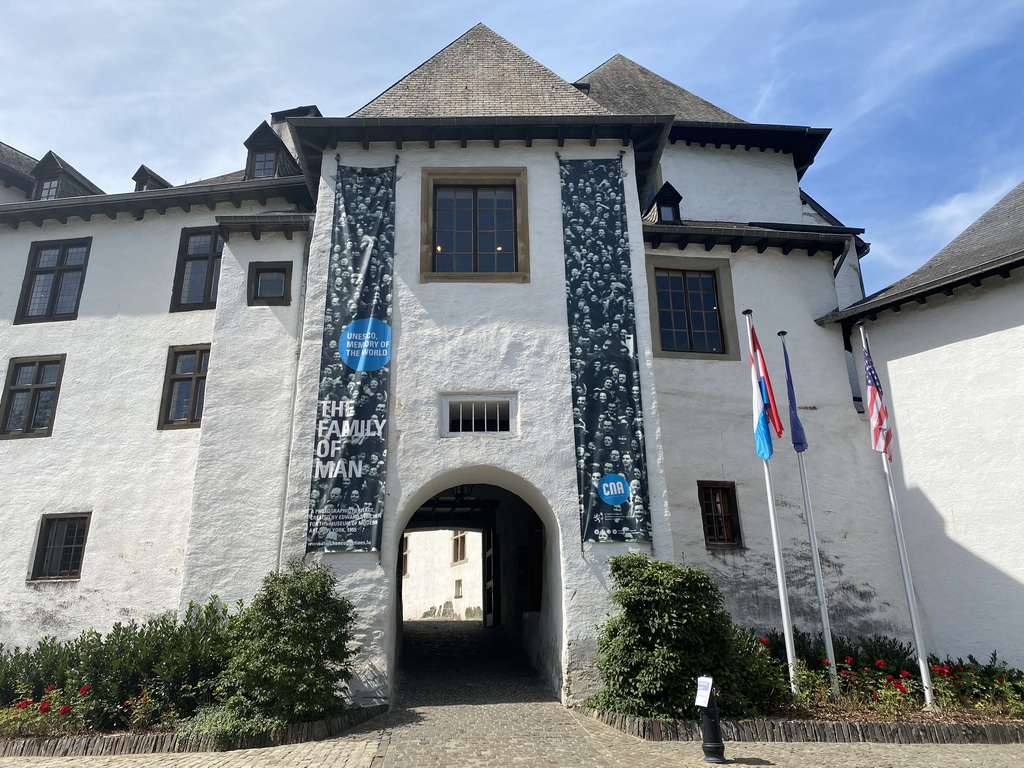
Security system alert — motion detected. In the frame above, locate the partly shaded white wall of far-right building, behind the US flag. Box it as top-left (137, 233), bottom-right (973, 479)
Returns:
top-left (858, 273), bottom-right (1024, 667)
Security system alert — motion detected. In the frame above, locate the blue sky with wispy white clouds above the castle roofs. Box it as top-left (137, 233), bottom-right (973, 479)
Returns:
top-left (0, 0), bottom-right (1024, 292)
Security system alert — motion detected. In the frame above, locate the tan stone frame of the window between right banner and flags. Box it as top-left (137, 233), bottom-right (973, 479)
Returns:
top-left (647, 254), bottom-right (739, 360)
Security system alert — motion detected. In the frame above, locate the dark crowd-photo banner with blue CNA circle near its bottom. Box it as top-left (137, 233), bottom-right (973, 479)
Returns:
top-left (559, 158), bottom-right (651, 542)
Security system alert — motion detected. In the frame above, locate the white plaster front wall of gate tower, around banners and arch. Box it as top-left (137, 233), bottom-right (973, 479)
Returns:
top-left (286, 142), bottom-right (668, 700)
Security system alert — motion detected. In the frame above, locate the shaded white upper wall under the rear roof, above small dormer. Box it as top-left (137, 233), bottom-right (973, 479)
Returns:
top-left (662, 141), bottom-right (803, 223)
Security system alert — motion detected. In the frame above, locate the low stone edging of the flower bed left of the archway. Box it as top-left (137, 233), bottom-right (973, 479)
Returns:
top-left (0, 705), bottom-right (388, 758)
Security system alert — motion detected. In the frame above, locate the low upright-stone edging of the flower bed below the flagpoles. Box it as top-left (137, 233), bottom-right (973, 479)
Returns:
top-left (572, 706), bottom-right (1024, 744)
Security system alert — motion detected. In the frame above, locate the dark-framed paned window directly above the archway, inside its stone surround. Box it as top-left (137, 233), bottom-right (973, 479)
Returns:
top-left (433, 185), bottom-right (517, 272)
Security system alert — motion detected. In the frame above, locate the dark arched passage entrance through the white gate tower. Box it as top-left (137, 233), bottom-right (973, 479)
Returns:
top-left (395, 478), bottom-right (562, 692)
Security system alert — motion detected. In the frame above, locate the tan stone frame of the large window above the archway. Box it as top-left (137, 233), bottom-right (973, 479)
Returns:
top-left (420, 167), bottom-right (529, 283)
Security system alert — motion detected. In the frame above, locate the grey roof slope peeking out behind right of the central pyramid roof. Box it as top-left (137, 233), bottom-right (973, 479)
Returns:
top-left (579, 53), bottom-right (744, 123)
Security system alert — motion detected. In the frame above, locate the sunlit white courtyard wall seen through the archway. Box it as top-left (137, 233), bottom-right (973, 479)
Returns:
top-left (401, 530), bottom-right (483, 622)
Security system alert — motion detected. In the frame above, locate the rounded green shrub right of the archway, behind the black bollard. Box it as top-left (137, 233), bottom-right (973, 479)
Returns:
top-left (588, 554), bottom-right (788, 719)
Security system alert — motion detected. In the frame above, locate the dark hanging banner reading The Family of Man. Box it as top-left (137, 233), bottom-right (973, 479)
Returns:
top-left (306, 165), bottom-right (395, 552)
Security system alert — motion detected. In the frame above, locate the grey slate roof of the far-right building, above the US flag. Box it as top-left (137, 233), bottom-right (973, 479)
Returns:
top-left (818, 181), bottom-right (1024, 324)
